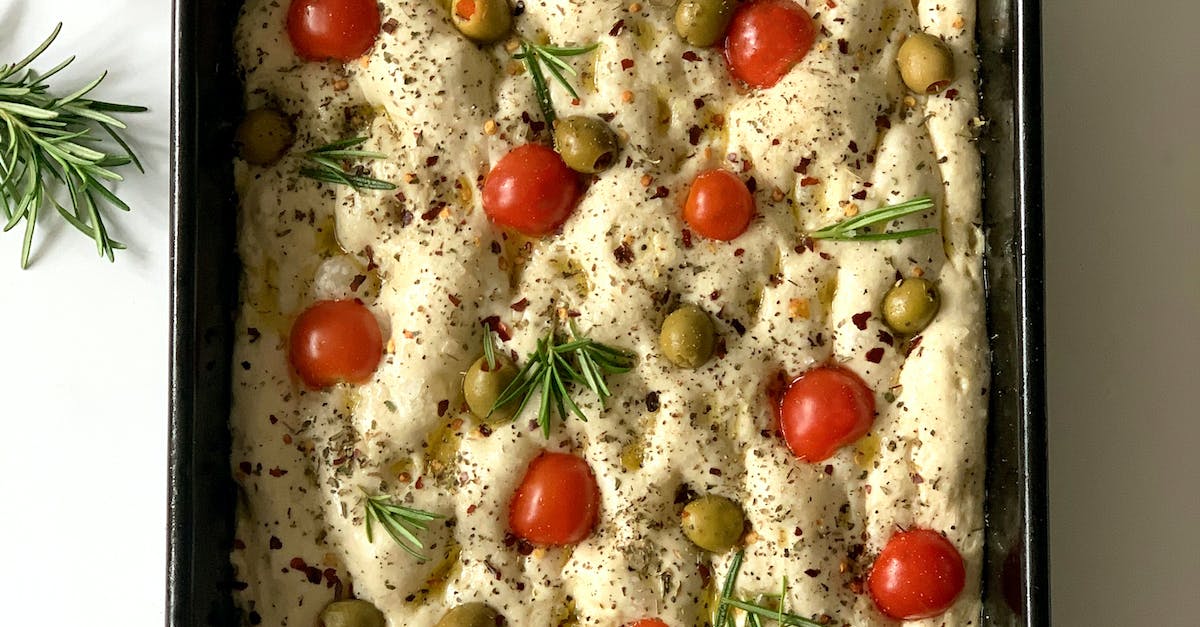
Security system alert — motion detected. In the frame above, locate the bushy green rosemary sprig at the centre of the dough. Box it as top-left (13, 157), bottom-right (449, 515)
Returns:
top-left (488, 321), bottom-right (634, 438)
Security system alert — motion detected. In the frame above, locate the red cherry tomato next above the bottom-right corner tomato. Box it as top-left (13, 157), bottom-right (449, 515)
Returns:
top-left (779, 365), bottom-right (875, 462)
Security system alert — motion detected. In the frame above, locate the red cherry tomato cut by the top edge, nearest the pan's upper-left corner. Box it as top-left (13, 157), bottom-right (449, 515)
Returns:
top-left (288, 0), bottom-right (379, 61)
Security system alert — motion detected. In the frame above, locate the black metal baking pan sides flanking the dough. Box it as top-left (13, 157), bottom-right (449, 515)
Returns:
top-left (167, 0), bottom-right (1050, 627)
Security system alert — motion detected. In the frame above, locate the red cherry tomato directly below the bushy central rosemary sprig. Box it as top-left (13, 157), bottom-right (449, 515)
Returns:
top-left (509, 452), bottom-right (600, 545)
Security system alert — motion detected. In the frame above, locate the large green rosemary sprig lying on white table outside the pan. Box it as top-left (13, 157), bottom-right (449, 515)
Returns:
top-left (0, 23), bottom-right (146, 268)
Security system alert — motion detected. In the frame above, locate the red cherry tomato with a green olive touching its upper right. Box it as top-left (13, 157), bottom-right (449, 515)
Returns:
top-left (484, 144), bottom-right (580, 235)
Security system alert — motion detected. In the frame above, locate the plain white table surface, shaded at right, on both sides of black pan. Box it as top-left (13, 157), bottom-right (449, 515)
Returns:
top-left (0, 0), bottom-right (1200, 627)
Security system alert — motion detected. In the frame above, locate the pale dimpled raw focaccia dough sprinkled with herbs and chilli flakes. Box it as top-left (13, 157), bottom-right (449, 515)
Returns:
top-left (232, 0), bottom-right (986, 627)
